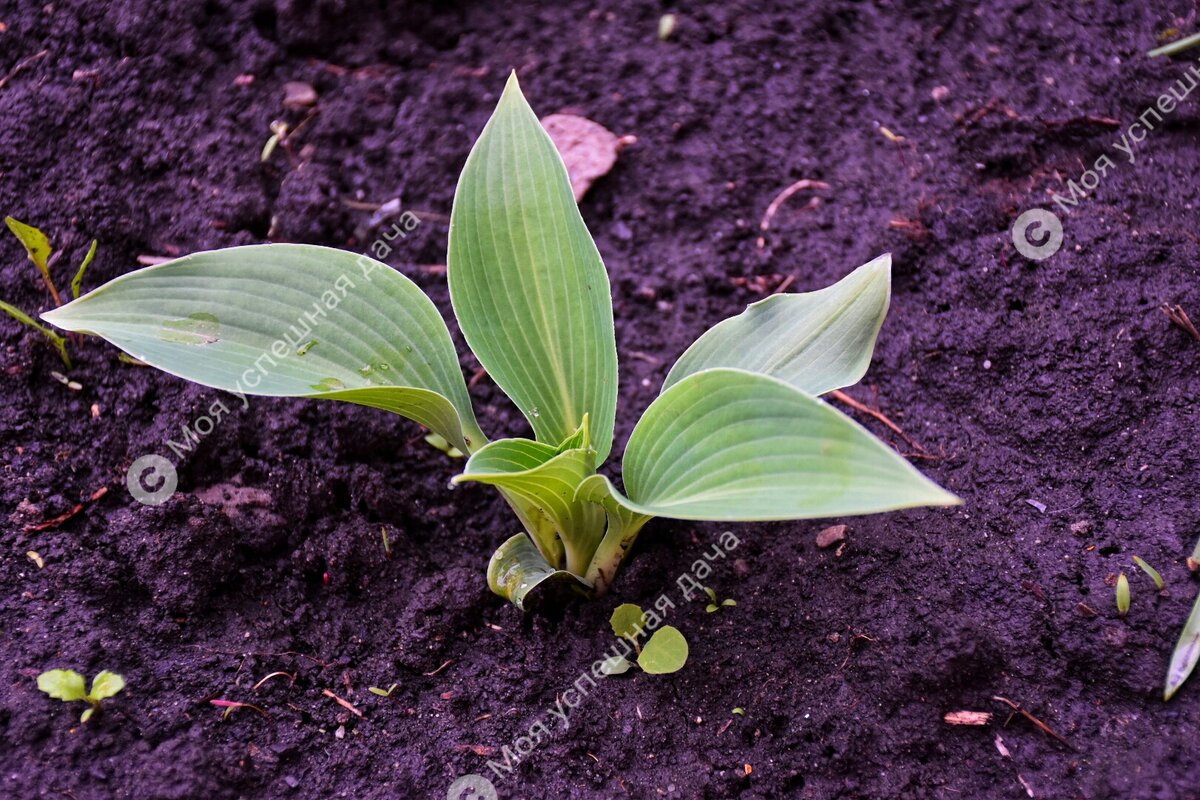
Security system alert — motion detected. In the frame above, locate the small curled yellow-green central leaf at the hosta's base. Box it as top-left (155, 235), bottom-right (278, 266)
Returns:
top-left (454, 417), bottom-right (604, 576)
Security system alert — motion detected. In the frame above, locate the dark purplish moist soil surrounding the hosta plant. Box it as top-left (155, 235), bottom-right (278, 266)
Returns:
top-left (0, 0), bottom-right (1200, 800)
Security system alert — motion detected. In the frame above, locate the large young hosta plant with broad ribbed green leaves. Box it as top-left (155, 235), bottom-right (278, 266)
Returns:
top-left (46, 76), bottom-right (959, 608)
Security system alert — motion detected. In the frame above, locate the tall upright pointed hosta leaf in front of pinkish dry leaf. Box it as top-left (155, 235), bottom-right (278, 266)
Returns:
top-left (446, 73), bottom-right (617, 463)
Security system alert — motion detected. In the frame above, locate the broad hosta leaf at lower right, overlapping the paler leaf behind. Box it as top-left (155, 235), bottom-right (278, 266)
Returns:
top-left (610, 369), bottom-right (960, 521)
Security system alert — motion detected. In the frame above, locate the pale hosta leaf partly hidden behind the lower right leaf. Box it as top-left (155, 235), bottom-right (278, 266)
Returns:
top-left (662, 254), bottom-right (892, 395)
